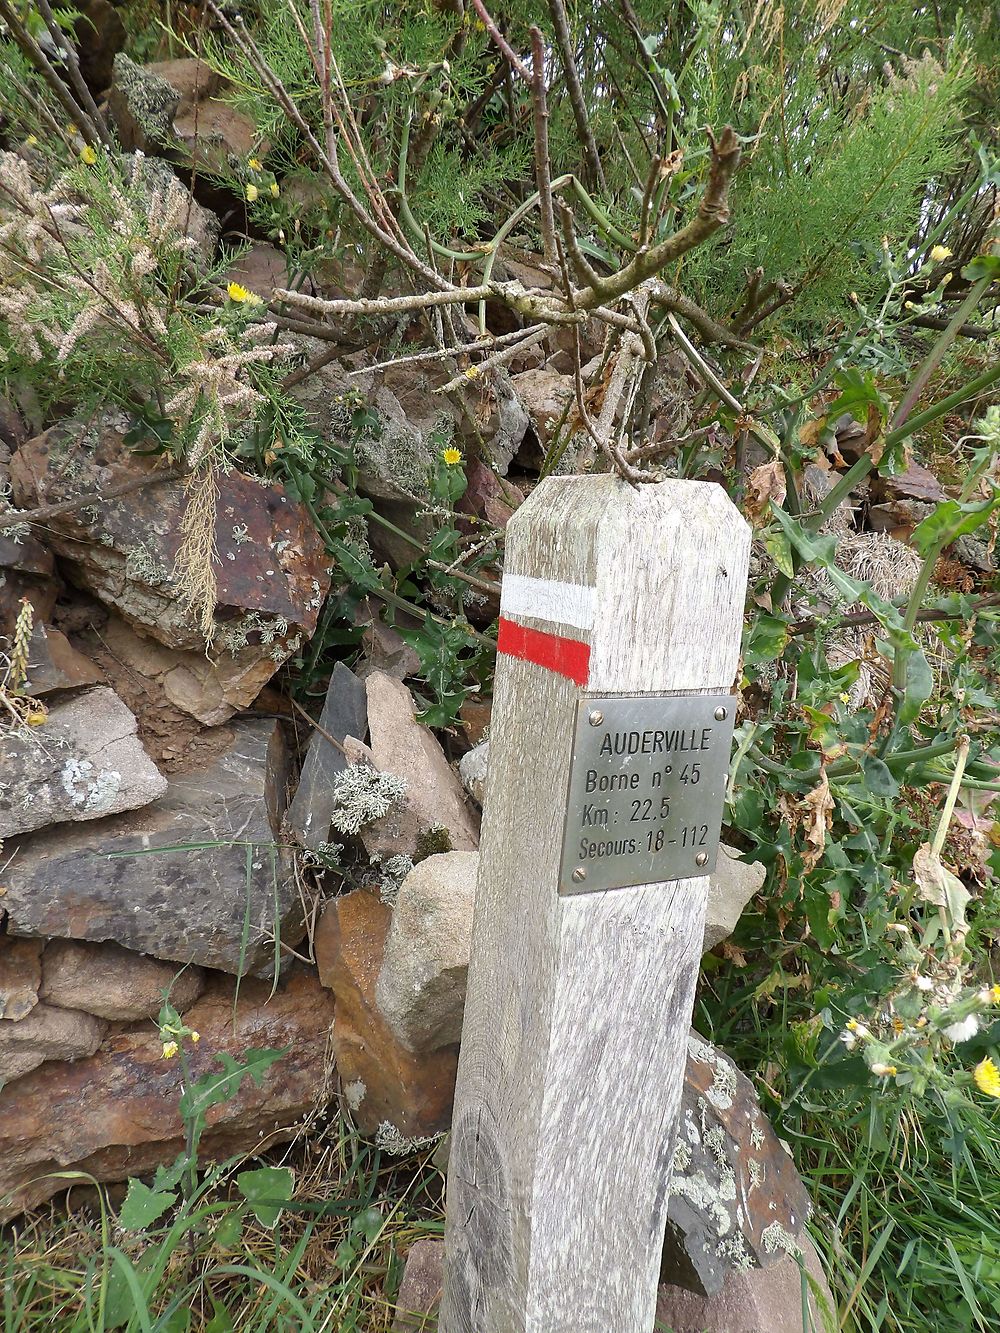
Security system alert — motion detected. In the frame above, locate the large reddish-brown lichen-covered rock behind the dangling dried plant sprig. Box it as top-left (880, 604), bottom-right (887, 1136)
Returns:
top-left (11, 412), bottom-right (329, 725)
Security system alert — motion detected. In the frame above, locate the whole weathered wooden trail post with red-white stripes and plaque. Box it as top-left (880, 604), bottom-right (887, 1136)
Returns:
top-left (439, 476), bottom-right (749, 1333)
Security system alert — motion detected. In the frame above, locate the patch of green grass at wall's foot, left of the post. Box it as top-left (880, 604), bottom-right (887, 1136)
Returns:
top-left (0, 1120), bottom-right (443, 1333)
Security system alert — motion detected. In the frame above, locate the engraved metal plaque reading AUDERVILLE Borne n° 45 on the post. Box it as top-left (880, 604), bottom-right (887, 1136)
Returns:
top-left (559, 694), bottom-right (736, 893)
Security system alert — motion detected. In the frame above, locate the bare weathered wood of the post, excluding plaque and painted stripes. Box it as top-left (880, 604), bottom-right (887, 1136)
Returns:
top-left (440, 476), bottom-right (749, 1333)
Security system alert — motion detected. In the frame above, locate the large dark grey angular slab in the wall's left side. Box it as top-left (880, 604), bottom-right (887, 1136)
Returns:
top-left (1, 718), bottom-right (303, 974)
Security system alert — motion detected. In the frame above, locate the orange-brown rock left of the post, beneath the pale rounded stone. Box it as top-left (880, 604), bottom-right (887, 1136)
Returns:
top-left (313, 889), bottom-right (459, 1138)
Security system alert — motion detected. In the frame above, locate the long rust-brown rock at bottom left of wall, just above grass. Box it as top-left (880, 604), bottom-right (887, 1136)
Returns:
top-left (0, 970), bottom-right (333, 1218)
